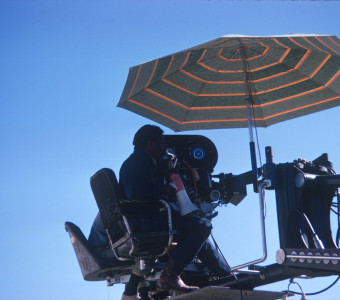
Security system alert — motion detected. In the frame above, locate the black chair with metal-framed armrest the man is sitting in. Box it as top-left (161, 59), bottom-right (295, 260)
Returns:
top-left (90, 168), bottom-right (172, 260)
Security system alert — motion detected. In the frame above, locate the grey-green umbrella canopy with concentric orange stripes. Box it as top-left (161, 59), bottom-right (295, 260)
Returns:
top-left (118, 35), bottom-right (340, 131)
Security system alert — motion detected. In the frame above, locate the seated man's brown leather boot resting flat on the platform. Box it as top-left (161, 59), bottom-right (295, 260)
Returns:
top-left (158, 258), bottom-right (198, 293)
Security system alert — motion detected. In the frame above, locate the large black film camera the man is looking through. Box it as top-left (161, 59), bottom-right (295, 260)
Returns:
top-left (164, 135), bottom-right (247, 205)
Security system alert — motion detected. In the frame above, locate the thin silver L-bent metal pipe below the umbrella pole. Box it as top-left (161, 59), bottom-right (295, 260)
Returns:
top-left (231, 180), bottom-right (270, 271)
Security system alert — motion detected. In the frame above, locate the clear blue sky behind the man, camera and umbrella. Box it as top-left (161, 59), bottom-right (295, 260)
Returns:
top-left (0, 0), bottom-right (340, 300)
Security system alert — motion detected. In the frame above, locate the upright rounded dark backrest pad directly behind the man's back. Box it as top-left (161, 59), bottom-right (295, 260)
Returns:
top-left (90, 168), bottom-right (121, 228)
